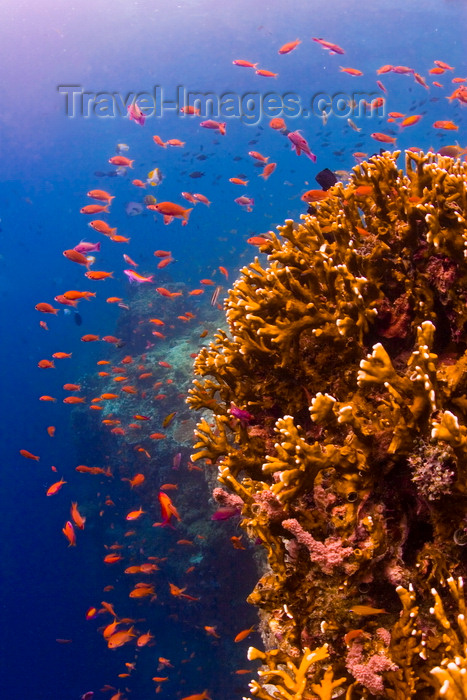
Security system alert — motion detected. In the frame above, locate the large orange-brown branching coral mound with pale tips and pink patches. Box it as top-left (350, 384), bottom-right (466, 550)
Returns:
top-left (188, 151), bottom-right (467, 700)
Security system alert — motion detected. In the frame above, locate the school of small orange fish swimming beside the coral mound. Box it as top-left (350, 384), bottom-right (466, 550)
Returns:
top-left (27, 32), bottom-right (467, 700)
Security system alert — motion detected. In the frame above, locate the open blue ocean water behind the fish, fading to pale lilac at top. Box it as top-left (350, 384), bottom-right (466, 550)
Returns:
top-left (0, 0), bottom-right (467, 700)
